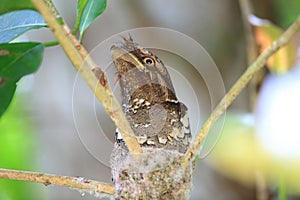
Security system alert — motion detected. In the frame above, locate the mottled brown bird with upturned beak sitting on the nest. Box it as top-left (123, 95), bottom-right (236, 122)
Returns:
top-left (111, 37), bottom-right (191, 153)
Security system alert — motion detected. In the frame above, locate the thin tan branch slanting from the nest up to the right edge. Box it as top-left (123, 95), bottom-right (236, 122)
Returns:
top-left (182, 15), bottom-right (300, 165)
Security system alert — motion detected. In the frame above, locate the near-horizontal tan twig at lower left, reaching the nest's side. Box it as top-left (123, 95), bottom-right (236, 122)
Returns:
top-left (0, 168), bottom-right (115, 195)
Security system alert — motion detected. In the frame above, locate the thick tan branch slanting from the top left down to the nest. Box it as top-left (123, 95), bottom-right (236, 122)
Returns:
top-left (32, 0), bottom-right (142, 154)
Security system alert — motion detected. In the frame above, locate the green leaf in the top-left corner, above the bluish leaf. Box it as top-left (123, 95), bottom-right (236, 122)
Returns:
top-left (0, 0), bottom-right (35, 15)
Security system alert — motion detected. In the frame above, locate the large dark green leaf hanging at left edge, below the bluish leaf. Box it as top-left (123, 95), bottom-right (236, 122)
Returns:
top-left (0, 42), bottom-right (44, 116)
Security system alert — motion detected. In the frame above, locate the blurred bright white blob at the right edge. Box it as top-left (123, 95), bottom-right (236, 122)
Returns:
top-left (256, 66), bottom-right (300, 159)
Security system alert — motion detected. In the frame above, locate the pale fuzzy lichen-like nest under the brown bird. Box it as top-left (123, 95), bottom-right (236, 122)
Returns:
top-left (111, 144), bottom-right (193, 200)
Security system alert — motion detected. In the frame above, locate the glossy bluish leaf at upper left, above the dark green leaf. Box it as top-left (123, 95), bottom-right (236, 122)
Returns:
top-left (0, 10), bottom-right (46, 43)
